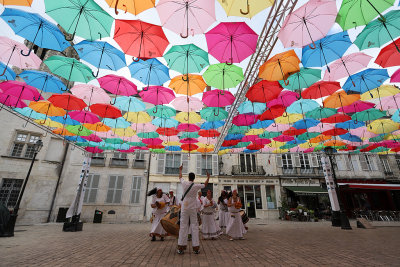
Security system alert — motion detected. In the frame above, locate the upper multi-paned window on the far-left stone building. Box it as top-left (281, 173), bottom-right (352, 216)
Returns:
top-left (10, 133), bottom-right (40, 159)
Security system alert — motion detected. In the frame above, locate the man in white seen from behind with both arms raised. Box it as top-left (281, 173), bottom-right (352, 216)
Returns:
top-left (178, 166), bottom-right (210, 254)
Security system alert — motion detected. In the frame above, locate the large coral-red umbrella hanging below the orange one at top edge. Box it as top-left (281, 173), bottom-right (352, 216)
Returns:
top-left (114, 20), bottom-right (169, 61)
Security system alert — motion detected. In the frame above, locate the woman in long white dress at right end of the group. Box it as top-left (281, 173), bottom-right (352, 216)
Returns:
top-left (226, 190), bottom-right (247, 241)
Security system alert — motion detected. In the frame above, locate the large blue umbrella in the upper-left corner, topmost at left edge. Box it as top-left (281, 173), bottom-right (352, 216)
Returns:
top-left (0, 8), bottom-right (70, 56)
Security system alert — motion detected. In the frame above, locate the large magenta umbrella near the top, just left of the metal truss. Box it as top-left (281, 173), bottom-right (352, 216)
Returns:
top-left (206, 22), bottom-right (258, 64)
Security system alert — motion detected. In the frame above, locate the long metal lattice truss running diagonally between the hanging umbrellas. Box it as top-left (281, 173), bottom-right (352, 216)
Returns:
top-left (214, 0), bottom-right (298, 153)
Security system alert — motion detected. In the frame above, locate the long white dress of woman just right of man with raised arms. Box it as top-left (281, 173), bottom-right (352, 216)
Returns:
top-left (201, 198), bottom-right (222, 239)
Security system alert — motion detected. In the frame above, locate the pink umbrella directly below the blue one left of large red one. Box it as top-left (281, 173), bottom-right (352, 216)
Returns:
top-left (97, 74), bottom-right (137, 99)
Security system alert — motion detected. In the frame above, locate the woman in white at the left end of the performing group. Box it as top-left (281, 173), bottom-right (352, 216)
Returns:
top-left (150, 189), bottom-right (169, 241)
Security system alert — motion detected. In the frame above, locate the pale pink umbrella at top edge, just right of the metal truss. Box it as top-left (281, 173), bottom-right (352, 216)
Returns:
top-left (278, 0), bottom-right (337, 48)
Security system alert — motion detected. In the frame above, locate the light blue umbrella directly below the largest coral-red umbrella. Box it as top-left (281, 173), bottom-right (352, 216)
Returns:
top-left (128, 58), bottom-right (171, 86)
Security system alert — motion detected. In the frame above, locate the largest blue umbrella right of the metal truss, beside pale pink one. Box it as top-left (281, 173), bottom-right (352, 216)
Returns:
top-left (301, 31), bottom-right (353, 72)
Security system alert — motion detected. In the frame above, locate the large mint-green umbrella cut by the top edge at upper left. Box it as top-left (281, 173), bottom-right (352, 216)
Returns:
top-left (44, 0), bottom-right (114, 41)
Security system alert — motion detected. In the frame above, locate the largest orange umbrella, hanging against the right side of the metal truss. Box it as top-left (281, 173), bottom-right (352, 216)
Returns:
top-left (258, 50), bottom-right (300, 85)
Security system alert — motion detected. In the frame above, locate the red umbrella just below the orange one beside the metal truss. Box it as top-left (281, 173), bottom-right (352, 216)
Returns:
top-left (246, 80), bottom-right (283, 103)
